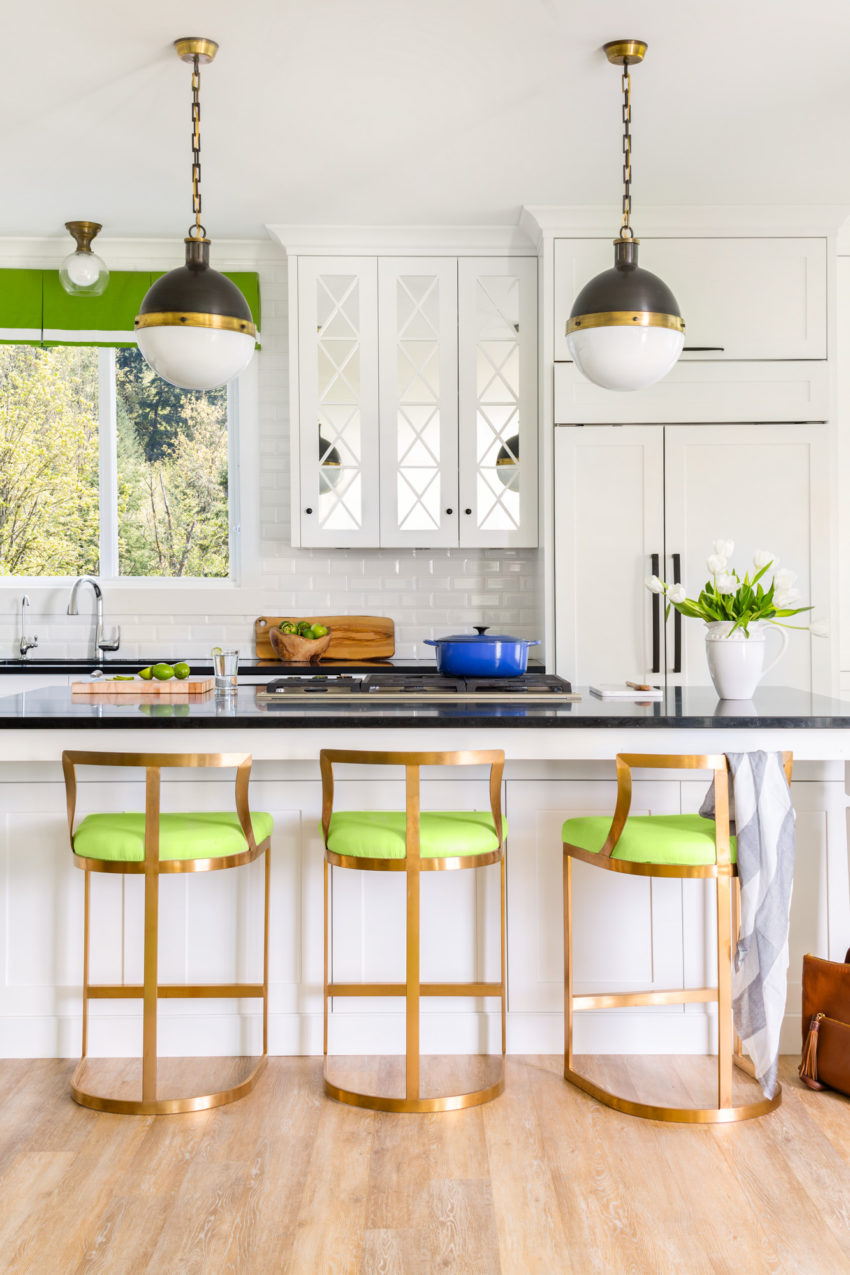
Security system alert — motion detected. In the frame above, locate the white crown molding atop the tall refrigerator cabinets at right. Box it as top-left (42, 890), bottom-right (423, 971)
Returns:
top-left (520, 204), bottom-right (850, 242)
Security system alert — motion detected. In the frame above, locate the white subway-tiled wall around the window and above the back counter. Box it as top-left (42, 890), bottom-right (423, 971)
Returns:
top-left (0, 238), bottom-right (543, 658)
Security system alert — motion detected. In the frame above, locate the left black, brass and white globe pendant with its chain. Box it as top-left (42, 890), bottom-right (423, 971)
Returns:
top-left (135, 37), bottom-right (256, 390)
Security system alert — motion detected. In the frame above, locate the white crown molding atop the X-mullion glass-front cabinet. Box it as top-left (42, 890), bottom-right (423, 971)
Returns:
top-left (266, 226), bottom-right (537, 256)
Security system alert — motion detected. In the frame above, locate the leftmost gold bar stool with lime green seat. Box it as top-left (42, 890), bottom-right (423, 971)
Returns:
top-left (62, 751), bottom-right (273, 1116)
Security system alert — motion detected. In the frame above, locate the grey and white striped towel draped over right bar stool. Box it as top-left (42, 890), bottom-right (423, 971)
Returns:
top-left (700, 752), bottom-right (795, 1098)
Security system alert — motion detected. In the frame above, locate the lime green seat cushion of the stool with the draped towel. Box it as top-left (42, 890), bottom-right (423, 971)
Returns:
top-left (562, 815), bottom-right (738, 866)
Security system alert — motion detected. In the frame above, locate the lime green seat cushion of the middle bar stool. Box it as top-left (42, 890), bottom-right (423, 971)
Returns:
top-left (322, 810), bottom-right (507, 859)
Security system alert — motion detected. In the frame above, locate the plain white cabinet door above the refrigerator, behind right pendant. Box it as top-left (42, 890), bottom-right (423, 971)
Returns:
top-left (554, 237), bottom-right (827, 361)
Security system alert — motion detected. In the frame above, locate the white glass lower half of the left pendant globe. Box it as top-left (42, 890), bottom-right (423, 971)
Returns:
top-left (136, 325), bottom-right (255, 390)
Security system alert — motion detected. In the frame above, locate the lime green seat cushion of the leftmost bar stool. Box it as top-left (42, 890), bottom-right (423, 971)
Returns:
top-left (74, 810), bottom-right (274, 863)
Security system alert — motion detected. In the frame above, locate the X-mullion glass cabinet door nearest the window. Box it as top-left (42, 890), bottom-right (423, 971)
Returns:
top-left (298, 256), bottom-right (380, 547)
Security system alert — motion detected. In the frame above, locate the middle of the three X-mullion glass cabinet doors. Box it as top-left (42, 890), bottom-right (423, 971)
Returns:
top-left (378, 256), bottom-right (457, 547)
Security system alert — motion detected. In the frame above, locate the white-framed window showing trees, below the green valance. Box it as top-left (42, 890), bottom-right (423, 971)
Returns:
top-left (0, 344), bottom-right (231, 578)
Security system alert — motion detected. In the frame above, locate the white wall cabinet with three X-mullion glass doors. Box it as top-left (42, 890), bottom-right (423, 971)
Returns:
top-left (291, 256), bottom-right (538, 547)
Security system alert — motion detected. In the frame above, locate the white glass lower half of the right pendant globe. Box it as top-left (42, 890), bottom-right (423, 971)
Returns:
top-left (567, 324), bottom-right (684, 390)
